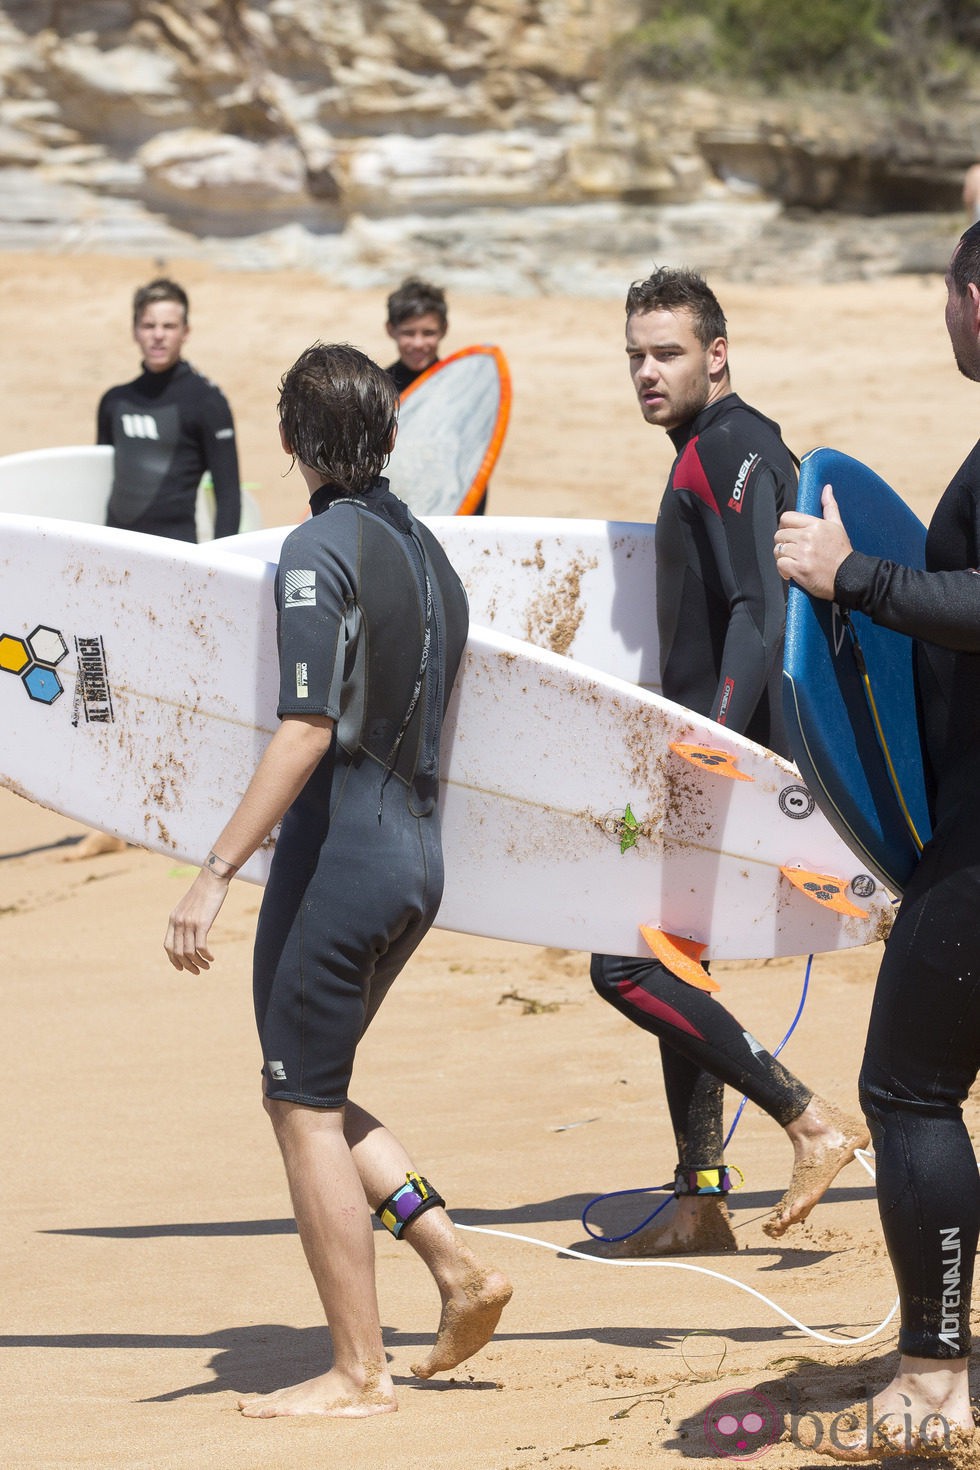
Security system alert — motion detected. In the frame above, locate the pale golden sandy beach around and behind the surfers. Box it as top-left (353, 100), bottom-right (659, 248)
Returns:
top-left (0, 241), bottom-right (980, 1470)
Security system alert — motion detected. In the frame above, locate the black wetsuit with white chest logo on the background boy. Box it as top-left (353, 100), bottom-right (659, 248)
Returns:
top-left (97, 359), bottom-right (241, 541)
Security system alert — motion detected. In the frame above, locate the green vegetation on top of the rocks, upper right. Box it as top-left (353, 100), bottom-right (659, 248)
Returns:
top-left (619, 0), bottom-right (980, 97)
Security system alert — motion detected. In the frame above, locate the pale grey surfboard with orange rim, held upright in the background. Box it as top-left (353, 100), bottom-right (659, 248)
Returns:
top-left (385, 345), bottom-right (511, 516)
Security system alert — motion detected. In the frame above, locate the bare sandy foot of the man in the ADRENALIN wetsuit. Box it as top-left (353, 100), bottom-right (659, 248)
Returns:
top-left (814, 1355), bottom-right (974, 1464)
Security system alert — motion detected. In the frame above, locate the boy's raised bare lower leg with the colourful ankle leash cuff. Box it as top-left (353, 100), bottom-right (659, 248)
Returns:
top-left (344, 1103), bottom-right (513, 1377)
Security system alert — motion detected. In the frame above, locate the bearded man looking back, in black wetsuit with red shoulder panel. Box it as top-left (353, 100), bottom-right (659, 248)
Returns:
top-left (592, 269), bottom-right (868, 1255)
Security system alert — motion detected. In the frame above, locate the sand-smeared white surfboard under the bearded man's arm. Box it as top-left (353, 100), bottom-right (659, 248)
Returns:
top-left (212, 516), bottom-right (660, 689)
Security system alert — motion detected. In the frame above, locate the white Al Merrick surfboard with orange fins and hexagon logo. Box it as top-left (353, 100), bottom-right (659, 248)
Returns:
top-left (0, 516), bottom-right (890, 958)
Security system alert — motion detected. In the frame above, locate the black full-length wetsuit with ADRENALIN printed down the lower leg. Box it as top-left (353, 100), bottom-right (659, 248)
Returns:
top-left (835, 432), bottom-right (980, 1358)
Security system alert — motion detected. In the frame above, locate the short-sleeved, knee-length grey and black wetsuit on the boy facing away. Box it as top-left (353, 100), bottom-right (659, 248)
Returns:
top-left (253, 479), bottom-right (467, 1108)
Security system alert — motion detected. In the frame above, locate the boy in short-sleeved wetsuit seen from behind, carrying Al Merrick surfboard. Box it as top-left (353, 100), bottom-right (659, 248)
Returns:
top-left (166, 344), bottom-right (511, 1419)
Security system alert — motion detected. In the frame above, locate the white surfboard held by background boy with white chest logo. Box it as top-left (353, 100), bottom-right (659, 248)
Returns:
top-left (0, 444), bottom-right (262, 541)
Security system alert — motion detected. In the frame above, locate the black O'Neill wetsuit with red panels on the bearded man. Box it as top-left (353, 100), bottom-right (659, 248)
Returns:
top-left (592, 394), bottom-right (813, 1173)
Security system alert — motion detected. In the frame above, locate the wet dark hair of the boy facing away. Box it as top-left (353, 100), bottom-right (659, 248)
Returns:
top-left (279, 343), bottom-right (398, 495)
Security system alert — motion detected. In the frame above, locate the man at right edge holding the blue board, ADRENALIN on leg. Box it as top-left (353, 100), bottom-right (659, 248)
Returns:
top-left (774, 223), bottom-right (980, 1463)
